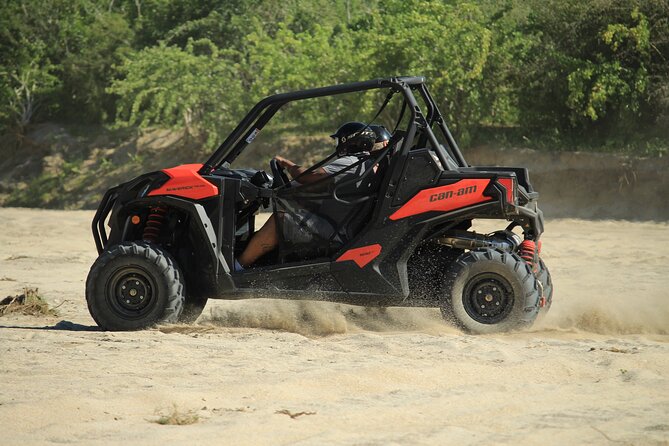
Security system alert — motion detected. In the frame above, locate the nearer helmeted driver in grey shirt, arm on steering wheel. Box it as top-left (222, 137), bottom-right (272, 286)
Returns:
top-left (235, 121), bottom-right (377, 271)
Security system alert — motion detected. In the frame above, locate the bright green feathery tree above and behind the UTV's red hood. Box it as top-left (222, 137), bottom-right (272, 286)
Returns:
top-left (108, 39), bottom-right (246, 144)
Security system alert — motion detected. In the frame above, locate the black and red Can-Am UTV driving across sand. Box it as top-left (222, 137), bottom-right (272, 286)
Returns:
top-left (86, 77), bottom-right (553, 333)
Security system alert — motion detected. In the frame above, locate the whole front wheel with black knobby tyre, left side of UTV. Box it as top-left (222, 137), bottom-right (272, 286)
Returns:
top-left (86, 242), bottom-right (185, 331)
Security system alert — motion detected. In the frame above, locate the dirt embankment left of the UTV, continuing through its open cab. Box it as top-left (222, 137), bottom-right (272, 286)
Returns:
top-left (0, 124), bottom-right (331, 209)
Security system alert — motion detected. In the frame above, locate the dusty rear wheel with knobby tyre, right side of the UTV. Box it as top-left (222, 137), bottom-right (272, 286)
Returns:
top-left (441, 249), bottom-right (541, 334)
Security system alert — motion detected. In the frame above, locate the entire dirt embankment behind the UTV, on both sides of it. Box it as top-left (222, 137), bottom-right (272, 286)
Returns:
top-left (0, 124), bottom-right (669, 220)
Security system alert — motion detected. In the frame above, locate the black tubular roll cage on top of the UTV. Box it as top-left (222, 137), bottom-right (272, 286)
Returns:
top-left (199, 76), bottom-right (468, 175)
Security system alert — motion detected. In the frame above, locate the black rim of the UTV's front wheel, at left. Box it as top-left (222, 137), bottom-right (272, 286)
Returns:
top-left (105, 266), bottom-right (157, 319)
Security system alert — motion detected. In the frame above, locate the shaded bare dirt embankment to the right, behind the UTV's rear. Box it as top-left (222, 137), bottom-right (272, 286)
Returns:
top-left (465, 147), bottom-right (669, 220)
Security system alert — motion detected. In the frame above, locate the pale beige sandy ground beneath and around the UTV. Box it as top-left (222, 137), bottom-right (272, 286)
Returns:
top-left (0, 208), bottom-right (669, 445)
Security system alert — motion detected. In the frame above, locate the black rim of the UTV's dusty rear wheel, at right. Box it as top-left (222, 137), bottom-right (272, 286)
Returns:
top-left (462, 273), bottom-right (514, 324)
